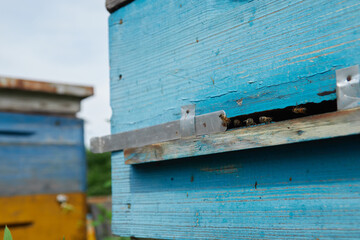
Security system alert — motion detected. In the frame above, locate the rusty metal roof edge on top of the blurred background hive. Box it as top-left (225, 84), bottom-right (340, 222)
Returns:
top-left (0, 76), bottom-right (94, 98)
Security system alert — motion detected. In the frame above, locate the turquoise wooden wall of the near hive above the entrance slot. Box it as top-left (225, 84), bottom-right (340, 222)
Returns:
top-left (109, 0), bottom-right (360, 133)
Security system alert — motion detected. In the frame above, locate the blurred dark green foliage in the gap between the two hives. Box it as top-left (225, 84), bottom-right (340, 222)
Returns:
top-left (86, 150), bottom-right (111, 196)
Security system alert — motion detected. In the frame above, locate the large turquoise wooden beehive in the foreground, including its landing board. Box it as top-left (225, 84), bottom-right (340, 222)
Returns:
top-left (100, 0), bottom-right (360, 239)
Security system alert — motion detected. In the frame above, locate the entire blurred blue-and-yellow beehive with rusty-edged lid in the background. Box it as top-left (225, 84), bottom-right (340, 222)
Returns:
top-left (0, 77), bottom-right (93, 240)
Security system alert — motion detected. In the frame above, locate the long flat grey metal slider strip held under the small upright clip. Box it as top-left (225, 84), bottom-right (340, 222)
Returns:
top-left (90, 109), bottom-right (227, 153)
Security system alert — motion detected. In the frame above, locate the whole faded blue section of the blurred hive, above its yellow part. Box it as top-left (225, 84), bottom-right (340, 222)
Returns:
top-left (0, 113), bottom-right (86, 196)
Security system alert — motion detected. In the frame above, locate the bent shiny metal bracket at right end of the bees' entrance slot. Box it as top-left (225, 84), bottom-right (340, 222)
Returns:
top-left (336, 65), bottom-right (360, 110)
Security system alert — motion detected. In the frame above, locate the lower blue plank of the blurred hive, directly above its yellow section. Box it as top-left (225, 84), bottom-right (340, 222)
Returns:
top-left (0, 145), bottom-right (86, 196)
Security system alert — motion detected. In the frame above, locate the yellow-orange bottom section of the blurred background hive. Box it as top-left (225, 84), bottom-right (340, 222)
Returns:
top-left (0, 193), bottom-right (87, 240)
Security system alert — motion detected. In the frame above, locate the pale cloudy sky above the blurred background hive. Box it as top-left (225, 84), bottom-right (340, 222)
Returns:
top-left (0, 0), bottom-right (111, 145)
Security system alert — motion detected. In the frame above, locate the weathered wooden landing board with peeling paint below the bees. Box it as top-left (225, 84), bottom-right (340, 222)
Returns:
top-left (124, 108), bottom-right (360, 164)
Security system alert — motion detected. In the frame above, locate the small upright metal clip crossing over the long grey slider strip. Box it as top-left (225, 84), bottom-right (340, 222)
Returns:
top-left (180, 105), bottom-right (195, 137)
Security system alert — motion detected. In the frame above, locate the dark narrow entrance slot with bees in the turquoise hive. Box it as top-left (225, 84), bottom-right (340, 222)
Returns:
top-left (228, 100), bottom-right (337, 130)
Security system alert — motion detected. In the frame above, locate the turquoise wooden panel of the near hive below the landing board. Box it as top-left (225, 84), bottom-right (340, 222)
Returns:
top-left (112, 135), bottom-right (360, 239)
